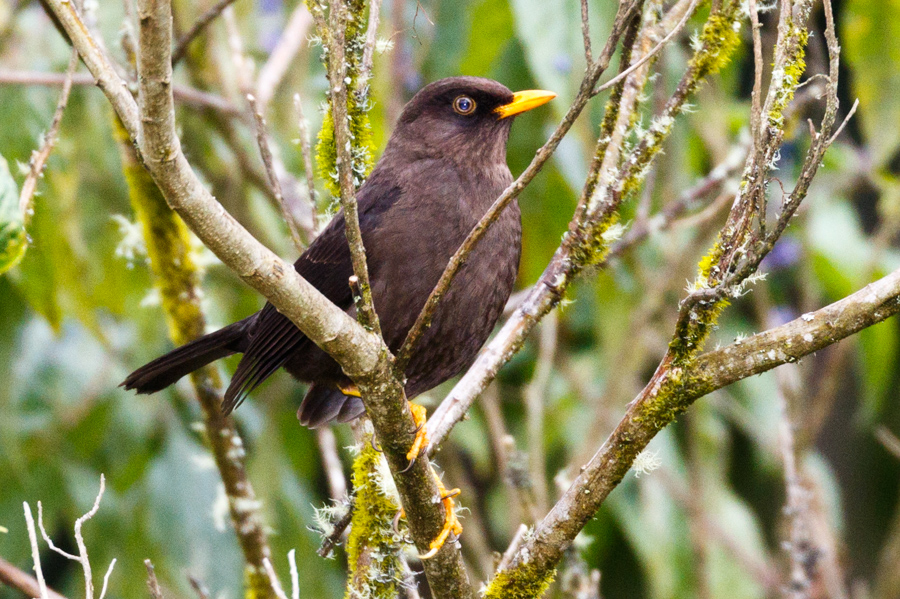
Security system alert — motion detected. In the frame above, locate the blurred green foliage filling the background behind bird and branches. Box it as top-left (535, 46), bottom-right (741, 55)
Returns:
top-left (0, 0), bottom-right (900, 599)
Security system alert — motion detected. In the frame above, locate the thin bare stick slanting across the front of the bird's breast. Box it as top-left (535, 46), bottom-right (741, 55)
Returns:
top-left (394, 1), bottom-right (637, 378)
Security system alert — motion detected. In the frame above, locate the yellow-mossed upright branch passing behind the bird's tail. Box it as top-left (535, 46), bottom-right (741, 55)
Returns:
top-left (114, 118), bottom-right (275, 599)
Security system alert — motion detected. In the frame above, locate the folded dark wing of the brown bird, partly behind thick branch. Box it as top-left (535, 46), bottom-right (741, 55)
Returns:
top-left (222, 173), bottom-right (401, 414)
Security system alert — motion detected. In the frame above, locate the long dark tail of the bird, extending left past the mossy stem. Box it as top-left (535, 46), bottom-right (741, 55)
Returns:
top-left (119, 316), bottom-right (252, 393)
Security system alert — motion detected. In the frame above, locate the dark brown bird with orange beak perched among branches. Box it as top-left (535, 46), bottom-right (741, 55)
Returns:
top-left (122, 77), bottom-right (555, 427)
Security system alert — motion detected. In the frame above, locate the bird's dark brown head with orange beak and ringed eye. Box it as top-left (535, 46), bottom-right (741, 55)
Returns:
top-left (387, 77), bottom-right (556, 164)
